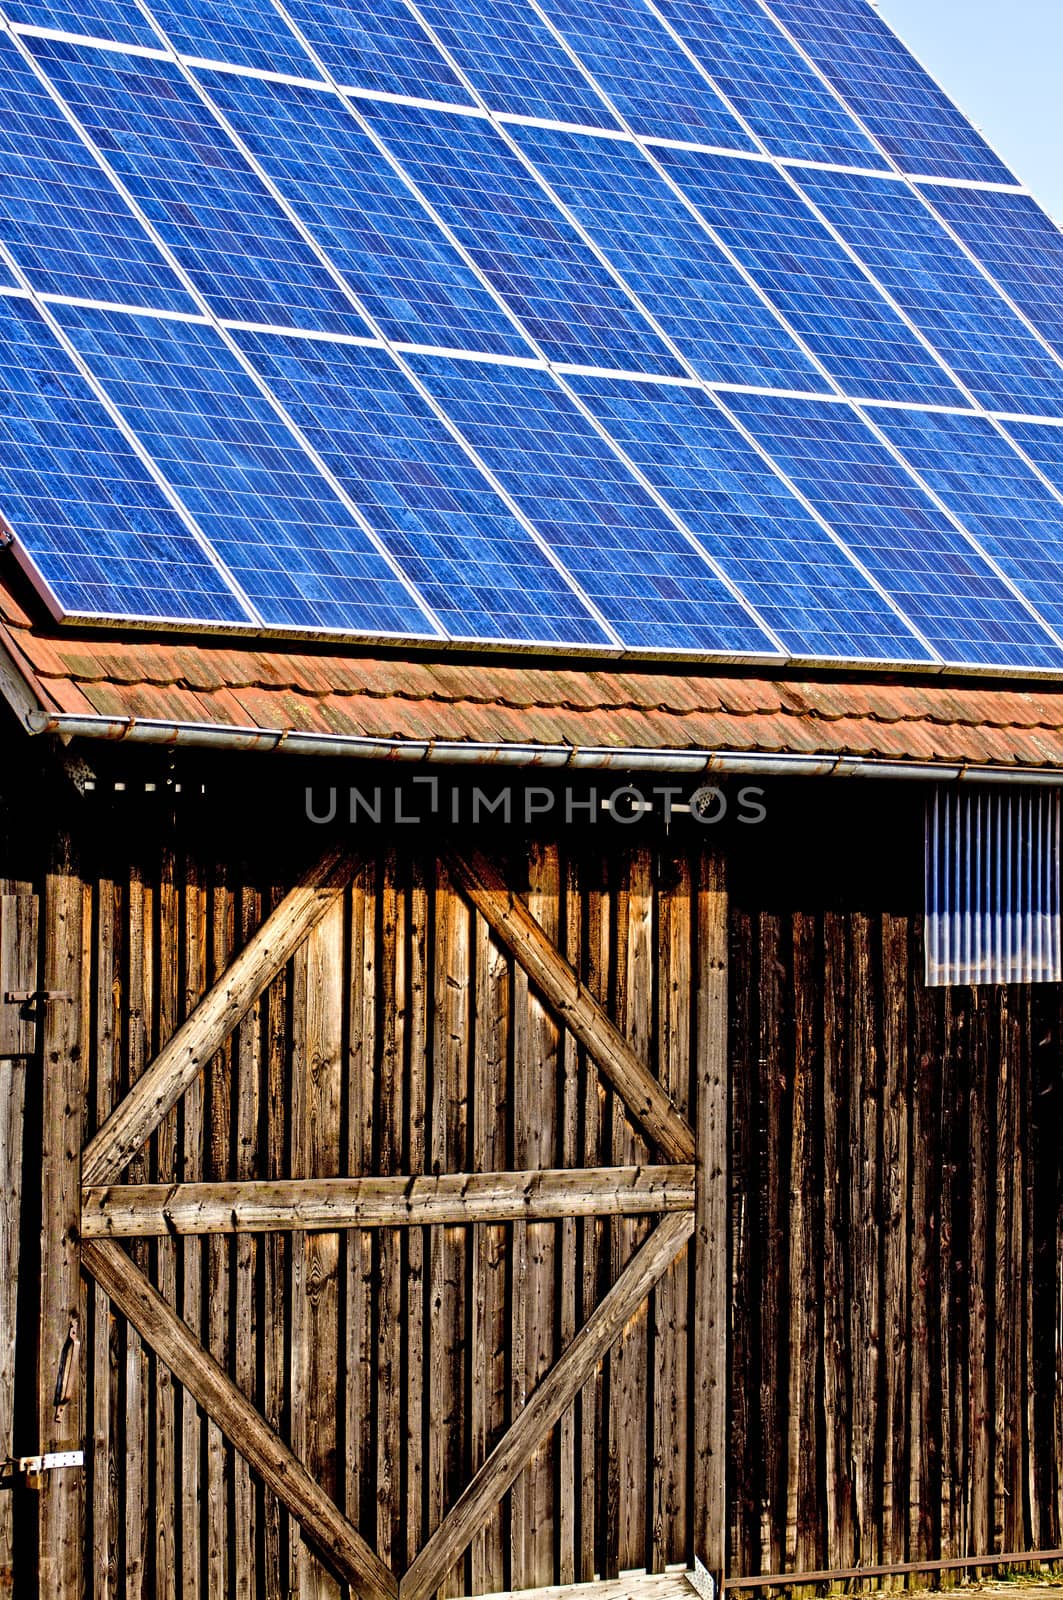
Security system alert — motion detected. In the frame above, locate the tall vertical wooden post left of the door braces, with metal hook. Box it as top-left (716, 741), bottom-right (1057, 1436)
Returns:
top-left (38, 834), bottom-right (88, 1600)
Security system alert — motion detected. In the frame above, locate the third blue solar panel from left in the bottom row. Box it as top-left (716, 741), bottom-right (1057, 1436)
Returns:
top-left (239, 333), bottom-right (608, 645)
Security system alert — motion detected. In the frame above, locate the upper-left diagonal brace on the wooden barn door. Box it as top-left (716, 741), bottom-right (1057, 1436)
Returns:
top-left (82, 848), bottom-right (354, 1184)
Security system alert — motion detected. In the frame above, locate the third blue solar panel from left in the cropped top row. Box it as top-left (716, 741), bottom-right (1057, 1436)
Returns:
top-left (285, 0), bottom-right (469, 106)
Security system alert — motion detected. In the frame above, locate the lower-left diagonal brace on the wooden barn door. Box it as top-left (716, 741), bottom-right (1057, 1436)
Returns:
top-left (82, 1240), bottom-right (399, 1600)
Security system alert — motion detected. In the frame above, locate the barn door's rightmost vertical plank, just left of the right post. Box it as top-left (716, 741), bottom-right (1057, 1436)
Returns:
top-left (650, 853), bottom-right (693, 1571)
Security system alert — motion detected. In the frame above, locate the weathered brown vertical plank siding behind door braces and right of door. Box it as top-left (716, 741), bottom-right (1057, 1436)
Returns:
top-left (0, 768), bottom-right (1063, 1600)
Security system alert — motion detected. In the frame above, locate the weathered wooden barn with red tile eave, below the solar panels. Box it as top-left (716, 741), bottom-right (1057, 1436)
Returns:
top-left (0, 581), bottom-right (1063, 1600)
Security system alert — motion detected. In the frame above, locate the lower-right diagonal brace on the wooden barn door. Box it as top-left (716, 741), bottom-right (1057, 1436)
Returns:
top-left (399, 1211), bottom-right (693, 1600)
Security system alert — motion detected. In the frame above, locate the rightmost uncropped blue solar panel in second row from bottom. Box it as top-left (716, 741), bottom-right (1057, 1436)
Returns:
top-left (658, 149), bottom-right (964, 405)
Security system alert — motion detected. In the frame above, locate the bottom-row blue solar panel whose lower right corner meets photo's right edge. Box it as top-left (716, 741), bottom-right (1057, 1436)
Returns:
top-left (728, 394), bottom-right (1063, 667)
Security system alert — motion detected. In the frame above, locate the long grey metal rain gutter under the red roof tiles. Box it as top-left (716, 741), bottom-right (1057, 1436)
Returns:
top-left (26, 710), bottom-right (1063, 786)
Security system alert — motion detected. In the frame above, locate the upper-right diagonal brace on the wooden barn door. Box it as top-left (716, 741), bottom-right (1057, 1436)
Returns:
top-left (447, 851), bottom-right (693, 1162)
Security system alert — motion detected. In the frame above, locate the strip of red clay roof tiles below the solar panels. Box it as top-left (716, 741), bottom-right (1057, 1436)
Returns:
top-left (0, 582), bottom-right (1063, 768)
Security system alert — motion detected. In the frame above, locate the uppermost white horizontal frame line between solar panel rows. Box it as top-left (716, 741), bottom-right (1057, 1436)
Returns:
top-left (0, 18), bottom-right (1033, 198)
